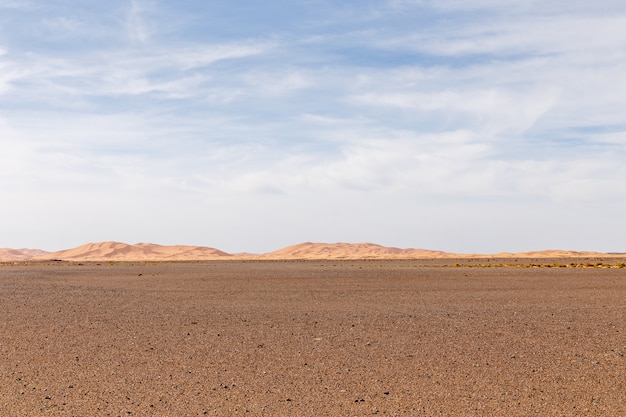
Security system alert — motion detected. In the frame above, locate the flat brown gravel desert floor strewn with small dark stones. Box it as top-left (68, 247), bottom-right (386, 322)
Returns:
top-left (0, 260), bottom-right (626, 417)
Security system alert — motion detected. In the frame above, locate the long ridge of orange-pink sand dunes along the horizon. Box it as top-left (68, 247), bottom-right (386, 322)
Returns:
top-left (0, 242), bottom-right (607, 262)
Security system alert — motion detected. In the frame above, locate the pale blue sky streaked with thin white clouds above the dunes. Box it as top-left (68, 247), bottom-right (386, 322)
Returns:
top-left (0, 0), bottom-right (626, 253)
